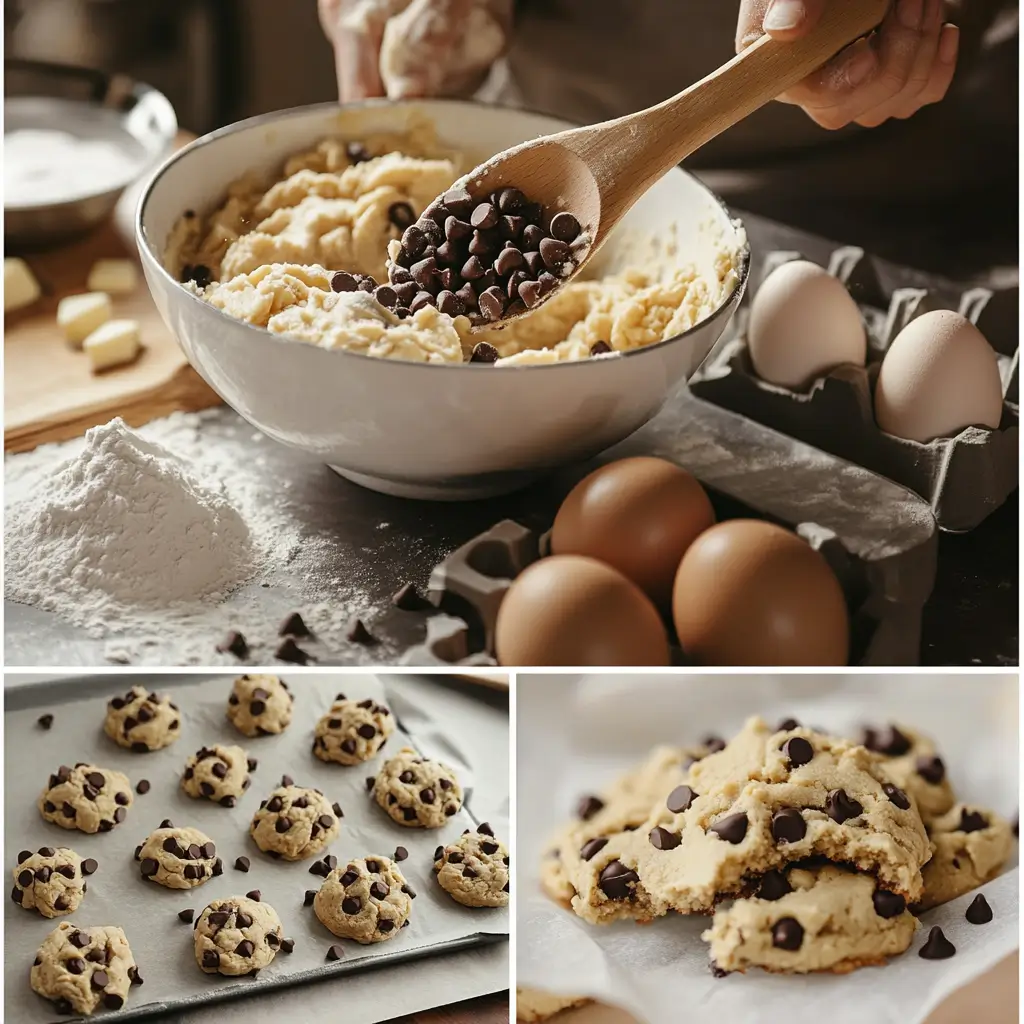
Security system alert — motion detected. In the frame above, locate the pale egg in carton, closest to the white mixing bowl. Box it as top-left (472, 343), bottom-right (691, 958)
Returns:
top-left (748, 260), bottom-right (867, 390)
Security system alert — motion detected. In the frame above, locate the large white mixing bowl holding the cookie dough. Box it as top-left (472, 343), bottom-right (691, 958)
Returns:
top-left (136, 100), bottom-right (749, 500)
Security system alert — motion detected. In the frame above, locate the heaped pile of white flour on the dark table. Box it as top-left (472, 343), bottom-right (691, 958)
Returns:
top-left (4, 419), bottom-right (254, 626)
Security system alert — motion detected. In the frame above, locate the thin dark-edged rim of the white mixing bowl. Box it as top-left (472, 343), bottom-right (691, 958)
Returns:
top-left (135, 96), bottom-right (751, 375)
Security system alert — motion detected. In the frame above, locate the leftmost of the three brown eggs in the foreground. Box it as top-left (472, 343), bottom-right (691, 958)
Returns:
top-left (495, 555), bottom-right (669, 665)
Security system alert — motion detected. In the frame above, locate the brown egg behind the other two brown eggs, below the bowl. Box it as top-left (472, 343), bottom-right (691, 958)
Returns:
top-left (551, 458), bottom-right (715, 611)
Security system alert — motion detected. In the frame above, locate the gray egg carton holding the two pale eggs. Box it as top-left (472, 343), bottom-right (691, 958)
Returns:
top-left (690, 246), bottom-right (1020, 531)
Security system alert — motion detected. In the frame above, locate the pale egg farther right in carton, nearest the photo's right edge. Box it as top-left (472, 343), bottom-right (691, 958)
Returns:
top-left (874, 309), bottom-right (1002, 444)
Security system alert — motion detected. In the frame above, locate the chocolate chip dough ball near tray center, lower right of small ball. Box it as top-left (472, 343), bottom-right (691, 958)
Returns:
top-left (249, 775), bottom-right (342, 860)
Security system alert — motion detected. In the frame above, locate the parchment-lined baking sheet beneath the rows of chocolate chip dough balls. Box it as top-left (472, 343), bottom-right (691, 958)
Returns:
top-left (4, 672), bottom-right (509, 1024)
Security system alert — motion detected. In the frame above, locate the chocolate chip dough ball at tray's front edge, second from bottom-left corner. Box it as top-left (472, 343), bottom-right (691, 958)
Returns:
top-left (194, 892), bottom-right (284, 977)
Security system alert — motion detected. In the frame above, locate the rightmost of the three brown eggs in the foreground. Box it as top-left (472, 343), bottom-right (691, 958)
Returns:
top-left (672, 519), bottom-right (849, 666)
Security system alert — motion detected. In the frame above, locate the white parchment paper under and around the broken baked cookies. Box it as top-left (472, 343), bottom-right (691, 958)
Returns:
top-left (517, 674), bottom-right (1019, 1024)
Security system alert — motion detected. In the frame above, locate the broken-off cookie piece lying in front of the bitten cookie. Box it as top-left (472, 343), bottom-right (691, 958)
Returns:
top-left (702, 865), bottom-right (918, 974)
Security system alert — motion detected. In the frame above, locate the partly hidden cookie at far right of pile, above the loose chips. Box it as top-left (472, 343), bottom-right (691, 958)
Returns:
top-left (919, 804), bottom-right (1014, 910)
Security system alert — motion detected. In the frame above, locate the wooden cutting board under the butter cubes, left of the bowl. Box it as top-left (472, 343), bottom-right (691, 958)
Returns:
top-left (4, 138), bottom-right (220, 452)
